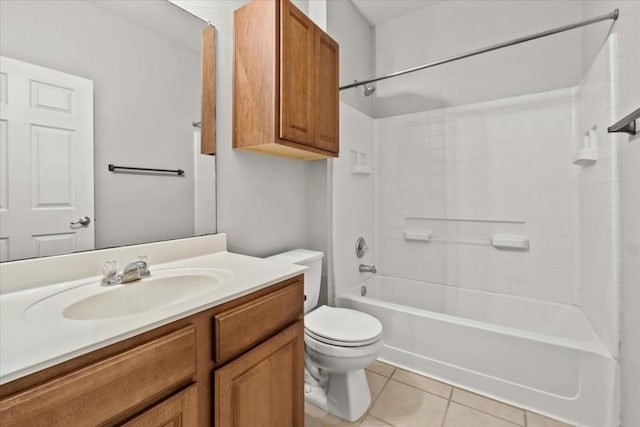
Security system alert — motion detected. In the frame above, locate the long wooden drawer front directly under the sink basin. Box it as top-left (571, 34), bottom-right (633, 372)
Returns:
top-left (0, 326), bottom-right (196, 427)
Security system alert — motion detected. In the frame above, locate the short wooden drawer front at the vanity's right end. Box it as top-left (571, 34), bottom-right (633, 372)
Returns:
top-left (213, 278), bottom-right (304, 362)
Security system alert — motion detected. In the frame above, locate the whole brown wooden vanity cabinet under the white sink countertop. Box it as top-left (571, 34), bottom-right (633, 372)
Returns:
top-left (0, 276), bottom-right (304, 427)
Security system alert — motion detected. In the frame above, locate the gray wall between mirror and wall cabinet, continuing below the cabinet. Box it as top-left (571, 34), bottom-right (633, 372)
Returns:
top-left (174, 0), bottom-right (309, 256)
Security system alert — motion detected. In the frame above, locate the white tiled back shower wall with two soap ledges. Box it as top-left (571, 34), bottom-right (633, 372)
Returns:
top-left (375, 89), bottom-right (579, 303)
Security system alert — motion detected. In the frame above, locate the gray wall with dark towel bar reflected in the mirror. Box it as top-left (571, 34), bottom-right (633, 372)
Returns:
top-left (0, 1), bottom-right (202, 248)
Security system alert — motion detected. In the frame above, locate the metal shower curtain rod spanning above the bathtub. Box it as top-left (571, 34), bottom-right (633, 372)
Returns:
top-left (340, 9), bottom-right (620, 90)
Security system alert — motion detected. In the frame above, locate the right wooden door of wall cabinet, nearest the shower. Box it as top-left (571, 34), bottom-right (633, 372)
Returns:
top-left (315, 28), bottom-right (340, 155)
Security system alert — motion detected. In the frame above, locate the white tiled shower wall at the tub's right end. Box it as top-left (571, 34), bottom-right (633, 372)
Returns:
top-left (575, 34), bottom-right (621, 356)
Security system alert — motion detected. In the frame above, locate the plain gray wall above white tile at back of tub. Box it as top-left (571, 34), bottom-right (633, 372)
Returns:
top-left (374, 0), bottom-right (582, 117)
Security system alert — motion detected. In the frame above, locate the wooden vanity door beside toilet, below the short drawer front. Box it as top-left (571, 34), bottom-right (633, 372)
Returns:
top-left (214, 320), bottom-right (304, 427)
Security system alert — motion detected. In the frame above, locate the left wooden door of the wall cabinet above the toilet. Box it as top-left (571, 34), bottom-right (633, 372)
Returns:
top-left (280, 1), bottom-right (315, 146)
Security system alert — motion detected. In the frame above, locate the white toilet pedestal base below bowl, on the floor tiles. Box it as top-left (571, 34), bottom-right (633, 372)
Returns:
top-left (305, 369), bottom-right (371, 421)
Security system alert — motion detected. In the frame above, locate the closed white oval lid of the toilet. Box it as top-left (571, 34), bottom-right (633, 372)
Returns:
top-left (304, 305), bottom-right (382, 347)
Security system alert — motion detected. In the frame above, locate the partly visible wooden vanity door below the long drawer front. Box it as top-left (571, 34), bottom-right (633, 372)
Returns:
top-left (123, 384), bottom-right (198, 427)
